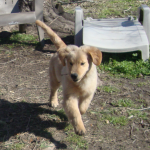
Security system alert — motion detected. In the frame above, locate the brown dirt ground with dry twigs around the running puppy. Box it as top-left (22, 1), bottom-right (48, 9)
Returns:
top-left (0, 26), bottom-right (150, 150)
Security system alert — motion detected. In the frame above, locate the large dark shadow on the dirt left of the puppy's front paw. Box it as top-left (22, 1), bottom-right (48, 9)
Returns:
top-left (0, 99), bottom-right (67, 149)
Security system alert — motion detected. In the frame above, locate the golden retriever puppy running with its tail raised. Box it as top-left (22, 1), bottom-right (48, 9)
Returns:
top-left (36, 20), bottom-right (102, 135)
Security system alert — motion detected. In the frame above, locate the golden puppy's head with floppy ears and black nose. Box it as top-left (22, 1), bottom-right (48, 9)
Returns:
top-left (58, 45), bottom-right (102, 82)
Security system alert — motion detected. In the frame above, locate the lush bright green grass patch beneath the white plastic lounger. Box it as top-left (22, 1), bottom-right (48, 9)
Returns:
top-left (100, 58), bottom-right (150, 79)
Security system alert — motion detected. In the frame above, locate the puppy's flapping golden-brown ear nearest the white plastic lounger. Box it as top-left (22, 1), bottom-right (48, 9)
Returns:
top-left (81, 45), bottom-right (102, 66)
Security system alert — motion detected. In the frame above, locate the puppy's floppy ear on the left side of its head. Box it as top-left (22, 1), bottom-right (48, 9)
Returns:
top-left (57, 47), bottom-right (68, 66)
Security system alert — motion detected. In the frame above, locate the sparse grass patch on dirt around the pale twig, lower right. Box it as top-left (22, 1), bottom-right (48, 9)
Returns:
top-left (97, 99), bottom-right (148, 127)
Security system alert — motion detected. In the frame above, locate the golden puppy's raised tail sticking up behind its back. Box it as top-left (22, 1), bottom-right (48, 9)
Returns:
top-left (36, 20), bottom-right (66, 49)
